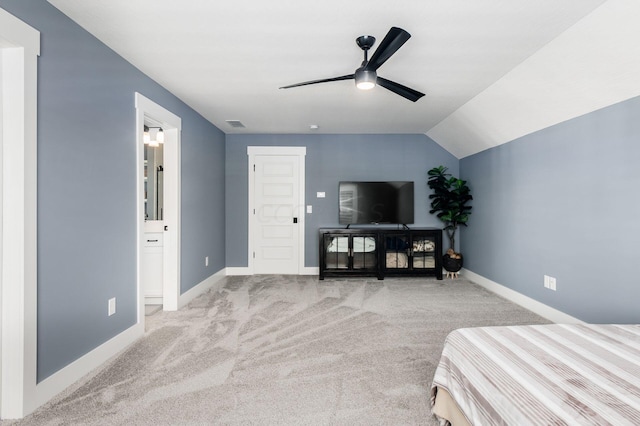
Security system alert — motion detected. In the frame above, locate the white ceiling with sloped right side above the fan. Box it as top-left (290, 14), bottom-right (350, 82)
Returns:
top-left (49, 0), bottom-right (640, 158)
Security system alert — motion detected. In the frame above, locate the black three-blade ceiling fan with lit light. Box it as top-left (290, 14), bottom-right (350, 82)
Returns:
top-left (281, 27), bottom-right (424, 102)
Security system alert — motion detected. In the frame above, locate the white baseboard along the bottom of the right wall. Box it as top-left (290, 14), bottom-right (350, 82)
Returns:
top-left (460, 268), bottom-right (584, 324)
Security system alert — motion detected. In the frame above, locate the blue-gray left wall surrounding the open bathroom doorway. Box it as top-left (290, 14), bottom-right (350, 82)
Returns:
top-left (0, 0), bottom-right (225, 381)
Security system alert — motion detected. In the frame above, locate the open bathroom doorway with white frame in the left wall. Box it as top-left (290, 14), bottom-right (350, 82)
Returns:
top-left (136, 93), bottom-right (181, 322)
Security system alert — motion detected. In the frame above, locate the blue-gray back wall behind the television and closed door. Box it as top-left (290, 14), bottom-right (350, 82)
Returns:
top-left (226, 134), bottom-right (458, 267)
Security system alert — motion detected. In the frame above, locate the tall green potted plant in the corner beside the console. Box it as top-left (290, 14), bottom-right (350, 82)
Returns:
top-left (427, 166), bottom-right (473, 272)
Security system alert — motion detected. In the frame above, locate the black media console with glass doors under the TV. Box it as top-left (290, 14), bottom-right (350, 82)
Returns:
top-left (319, 228), bottom-right (442, 280)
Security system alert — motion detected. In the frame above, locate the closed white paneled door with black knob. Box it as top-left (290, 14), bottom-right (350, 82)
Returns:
top-left (250, 148), bottom-right (304, 274)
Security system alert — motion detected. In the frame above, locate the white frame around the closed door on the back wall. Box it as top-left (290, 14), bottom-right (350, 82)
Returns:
top-left (247, 146), bottom-right (307, 275)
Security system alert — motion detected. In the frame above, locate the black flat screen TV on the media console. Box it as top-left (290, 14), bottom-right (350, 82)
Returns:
top-left (339, 182), bottom-right (413, 225)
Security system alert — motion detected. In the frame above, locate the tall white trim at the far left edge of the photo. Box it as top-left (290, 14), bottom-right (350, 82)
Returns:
top-left (0, 9), bottom-right (40, 419)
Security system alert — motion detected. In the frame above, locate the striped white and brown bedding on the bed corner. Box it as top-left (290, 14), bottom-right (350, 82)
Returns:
top-left (431, 324), bottom-right (640, 426)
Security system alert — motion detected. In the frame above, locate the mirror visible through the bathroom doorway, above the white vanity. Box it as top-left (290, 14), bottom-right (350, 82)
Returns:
top-left (144, 144), bottom-right (164, 220)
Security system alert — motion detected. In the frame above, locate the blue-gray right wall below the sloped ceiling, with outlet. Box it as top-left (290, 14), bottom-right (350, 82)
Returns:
top-left (460, 98), bottom-right (640, 323)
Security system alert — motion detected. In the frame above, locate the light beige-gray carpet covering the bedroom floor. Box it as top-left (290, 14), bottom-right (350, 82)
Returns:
top-left (12, 276), bottom-right (548, 425)
